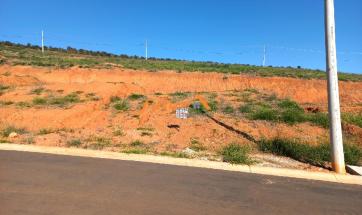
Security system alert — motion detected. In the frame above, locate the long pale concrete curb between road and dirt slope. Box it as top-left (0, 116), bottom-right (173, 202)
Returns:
top-left (0, 144), bottom-right (362, 185)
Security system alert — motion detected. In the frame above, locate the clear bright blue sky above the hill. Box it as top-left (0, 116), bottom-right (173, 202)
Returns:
top-left (0, 0), bottom-right (362, 73)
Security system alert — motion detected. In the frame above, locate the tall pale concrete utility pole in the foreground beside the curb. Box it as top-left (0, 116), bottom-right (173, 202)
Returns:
top-left (325, 0), bottom-right (346, 174)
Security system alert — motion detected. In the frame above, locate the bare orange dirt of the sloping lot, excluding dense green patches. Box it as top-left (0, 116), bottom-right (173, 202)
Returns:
top-left (0, 66), bottom-right (362, 169)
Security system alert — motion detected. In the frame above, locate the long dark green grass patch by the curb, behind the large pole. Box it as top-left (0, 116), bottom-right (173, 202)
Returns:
top-left (258, 138), bottom-right (362, 166)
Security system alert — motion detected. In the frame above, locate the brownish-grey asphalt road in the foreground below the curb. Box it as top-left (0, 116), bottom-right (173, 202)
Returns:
top-left (0, 151), bottom-right (362, 215)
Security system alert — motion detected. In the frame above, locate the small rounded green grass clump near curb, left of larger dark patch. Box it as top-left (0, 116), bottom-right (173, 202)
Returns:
top-left (221, 143), bottom-right (255, 165)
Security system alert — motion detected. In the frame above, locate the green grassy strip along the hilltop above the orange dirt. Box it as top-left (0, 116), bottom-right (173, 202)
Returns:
top-left (0, 41), bottom-right (362, 81)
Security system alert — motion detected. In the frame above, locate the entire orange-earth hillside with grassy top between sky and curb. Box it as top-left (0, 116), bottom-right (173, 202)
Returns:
top-left (0, 43), bottom-right (362, 171)
